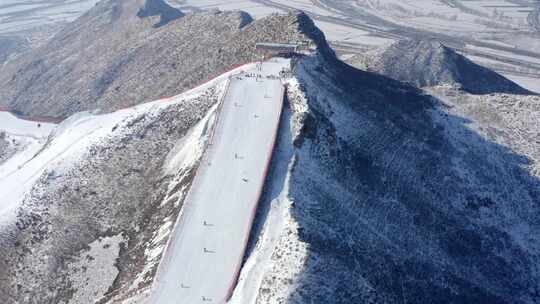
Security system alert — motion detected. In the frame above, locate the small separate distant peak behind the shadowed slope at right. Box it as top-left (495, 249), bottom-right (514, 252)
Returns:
top-left (351, 40), bottom-right (530, 94)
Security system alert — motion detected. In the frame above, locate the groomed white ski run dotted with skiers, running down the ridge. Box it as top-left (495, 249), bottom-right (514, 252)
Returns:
top-left (150, 59), bottom-right (290, 304)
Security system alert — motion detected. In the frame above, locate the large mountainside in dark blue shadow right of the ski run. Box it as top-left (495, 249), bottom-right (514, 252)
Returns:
top-left (236, 48), bottom-right (540, 303)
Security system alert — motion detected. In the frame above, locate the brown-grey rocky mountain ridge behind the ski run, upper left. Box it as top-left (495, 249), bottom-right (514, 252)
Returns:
top-left (0, 0), bottom-right (322, 117)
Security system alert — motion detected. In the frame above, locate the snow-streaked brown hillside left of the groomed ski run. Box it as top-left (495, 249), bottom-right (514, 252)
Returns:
top-left (0, 78), bottom-right (230, 304)
